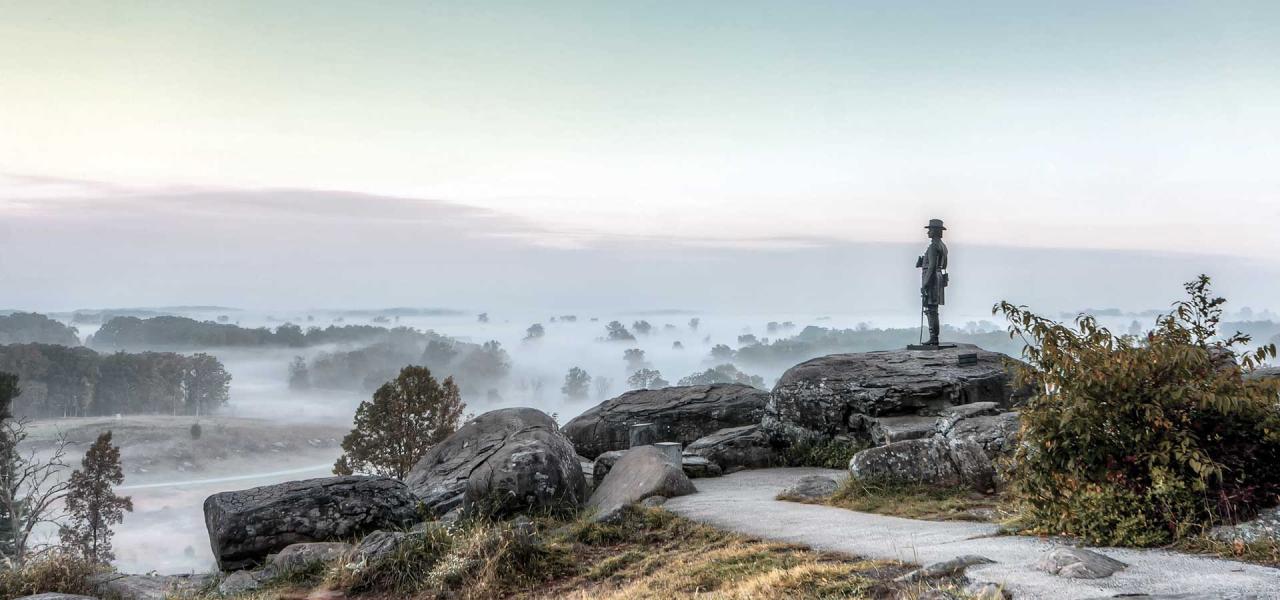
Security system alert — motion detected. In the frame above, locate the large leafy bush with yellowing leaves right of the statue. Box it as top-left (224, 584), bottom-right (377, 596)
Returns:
top-left (993, 275), bottom-right (1280, 545)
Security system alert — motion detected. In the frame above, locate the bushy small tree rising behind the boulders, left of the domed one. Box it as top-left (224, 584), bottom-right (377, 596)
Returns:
top-left (333, 365), bottom-right (466, 478)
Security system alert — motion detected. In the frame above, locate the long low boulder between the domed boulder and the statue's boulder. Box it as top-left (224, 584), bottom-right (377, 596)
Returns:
top-left (564, 384), bottom-right (769, 458)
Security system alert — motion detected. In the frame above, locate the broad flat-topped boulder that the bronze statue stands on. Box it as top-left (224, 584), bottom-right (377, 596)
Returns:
top-left (762, 344), bottom-right (1025, 441)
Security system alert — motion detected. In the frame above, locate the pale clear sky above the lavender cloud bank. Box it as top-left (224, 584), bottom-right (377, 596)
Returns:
top-left (0, 0), bottom-right (1280, 308)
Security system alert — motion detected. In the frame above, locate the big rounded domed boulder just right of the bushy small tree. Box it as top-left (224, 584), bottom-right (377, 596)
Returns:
top-left (404, 408), bottom-right (586, 516)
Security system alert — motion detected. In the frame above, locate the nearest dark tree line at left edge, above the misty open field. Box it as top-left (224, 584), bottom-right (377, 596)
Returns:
top-left (0, 344), bottom-right (232, 417)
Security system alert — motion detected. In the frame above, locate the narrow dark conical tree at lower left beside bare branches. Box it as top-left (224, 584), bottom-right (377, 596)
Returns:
top-left (60, 431), bottom-right (133, 564)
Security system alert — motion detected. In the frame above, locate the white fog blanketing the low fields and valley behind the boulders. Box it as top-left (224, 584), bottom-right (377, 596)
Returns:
top-left (7, 305), bottom-right (1271, 573)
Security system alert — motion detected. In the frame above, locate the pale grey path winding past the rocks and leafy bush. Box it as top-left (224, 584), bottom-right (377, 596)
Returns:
top-left (666, 468), bottom-right (1280, 600)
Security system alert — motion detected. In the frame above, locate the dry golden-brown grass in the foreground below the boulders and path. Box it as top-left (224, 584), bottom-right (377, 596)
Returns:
top-left (194, 508), bottom-right (993, 600)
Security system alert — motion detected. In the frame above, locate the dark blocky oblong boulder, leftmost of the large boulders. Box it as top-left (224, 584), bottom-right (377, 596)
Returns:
top-left (205, 476), bottom-right (419, 571)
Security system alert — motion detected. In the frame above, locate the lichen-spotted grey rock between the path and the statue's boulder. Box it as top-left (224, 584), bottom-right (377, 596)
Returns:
top-left (849, 438), bottom-right (996, 491)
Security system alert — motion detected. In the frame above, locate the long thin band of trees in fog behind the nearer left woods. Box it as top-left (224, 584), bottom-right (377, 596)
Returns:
top-left (88, 316), bottom-right (428, 349)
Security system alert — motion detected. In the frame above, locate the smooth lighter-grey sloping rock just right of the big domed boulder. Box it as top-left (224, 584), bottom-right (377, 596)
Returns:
top-left (586, 445), bottom-right (698, 519)
